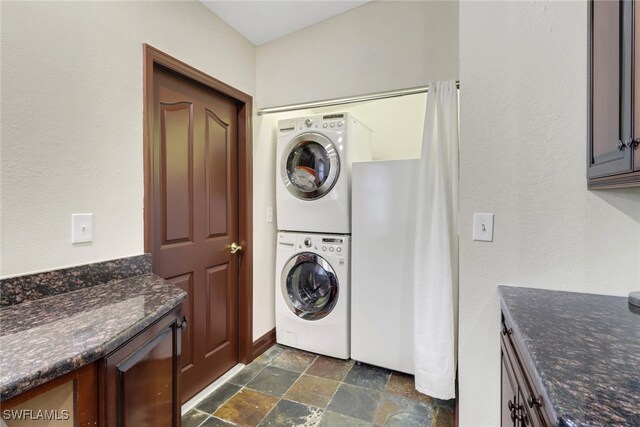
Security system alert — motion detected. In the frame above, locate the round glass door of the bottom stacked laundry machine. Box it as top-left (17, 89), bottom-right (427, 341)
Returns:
top-left (281, 252), bottom-right (339, 320)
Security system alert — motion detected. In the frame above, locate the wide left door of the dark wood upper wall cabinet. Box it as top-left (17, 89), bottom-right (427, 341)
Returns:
top-left (587, 0), bottom-right (632, 178)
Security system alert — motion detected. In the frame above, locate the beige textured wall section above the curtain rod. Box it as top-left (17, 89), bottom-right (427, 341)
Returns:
top-left (257, 1), bottom-right (458, 108)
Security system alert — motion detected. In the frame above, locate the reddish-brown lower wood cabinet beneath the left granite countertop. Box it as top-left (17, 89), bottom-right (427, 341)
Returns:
top-left (2, 306), bottom-right (186, 427)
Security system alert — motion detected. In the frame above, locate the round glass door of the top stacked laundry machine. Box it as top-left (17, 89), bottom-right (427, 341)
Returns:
top-left (280, 132), bottom-right (340, 200)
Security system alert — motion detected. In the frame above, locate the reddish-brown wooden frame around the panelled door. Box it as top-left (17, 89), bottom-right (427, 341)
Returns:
top-left (143, 43), bottom-right (253, 364)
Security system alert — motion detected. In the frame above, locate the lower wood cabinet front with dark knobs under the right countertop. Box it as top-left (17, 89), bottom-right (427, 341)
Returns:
top-left (500, 315), bottom-right (557, 427)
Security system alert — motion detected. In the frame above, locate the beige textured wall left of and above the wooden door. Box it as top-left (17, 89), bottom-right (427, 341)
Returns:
top-left (0, 1), bottom-right (256, 276)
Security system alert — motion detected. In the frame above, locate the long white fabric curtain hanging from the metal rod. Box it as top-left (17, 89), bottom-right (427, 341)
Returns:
top-left (414, 80), bottom-right (459, 399)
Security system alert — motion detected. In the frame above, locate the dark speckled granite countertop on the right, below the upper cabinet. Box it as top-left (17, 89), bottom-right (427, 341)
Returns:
top-left (498, 286), bottom-right (640, 426)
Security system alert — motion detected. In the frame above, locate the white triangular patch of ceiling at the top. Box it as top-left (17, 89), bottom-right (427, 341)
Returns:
top-left (200, 0), bottom-right (370, 45)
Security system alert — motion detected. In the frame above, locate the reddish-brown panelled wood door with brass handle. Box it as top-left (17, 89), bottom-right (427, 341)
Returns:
top-left (151, 69), bottom-right (240, 402)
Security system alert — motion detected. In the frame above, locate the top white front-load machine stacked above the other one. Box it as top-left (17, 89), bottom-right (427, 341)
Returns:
top-left (276, 113), bottom-right (372, 234)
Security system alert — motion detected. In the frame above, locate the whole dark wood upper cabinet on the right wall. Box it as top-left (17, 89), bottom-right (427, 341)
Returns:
top-left (587, 0), bottom-right (640, 189)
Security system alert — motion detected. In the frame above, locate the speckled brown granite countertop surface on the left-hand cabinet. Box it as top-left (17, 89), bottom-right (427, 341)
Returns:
top-left (0, 273), bottom-right (186, 400)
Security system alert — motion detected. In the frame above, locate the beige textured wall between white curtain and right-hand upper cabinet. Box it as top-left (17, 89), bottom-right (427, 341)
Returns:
top-left (458, 1), bottom-right (640, 427)
